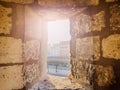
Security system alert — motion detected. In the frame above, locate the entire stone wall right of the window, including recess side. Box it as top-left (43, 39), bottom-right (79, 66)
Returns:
top-left (71, 0), bottom-right (120, 90)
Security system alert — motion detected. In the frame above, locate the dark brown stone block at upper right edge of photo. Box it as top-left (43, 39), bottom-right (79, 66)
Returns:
top-left (110, 4), bottom-right (120, 30)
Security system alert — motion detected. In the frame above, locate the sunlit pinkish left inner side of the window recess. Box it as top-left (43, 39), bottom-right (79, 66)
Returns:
top-left (24, 6), bottom-right (47, 88)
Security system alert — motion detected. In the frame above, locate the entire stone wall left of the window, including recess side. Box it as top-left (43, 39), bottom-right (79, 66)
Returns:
top-left (0, 0), bottom-right (47, 90)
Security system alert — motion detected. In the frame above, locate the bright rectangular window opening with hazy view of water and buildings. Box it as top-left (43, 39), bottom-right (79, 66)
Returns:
top-left (47, 19), bottom-right (71, 77)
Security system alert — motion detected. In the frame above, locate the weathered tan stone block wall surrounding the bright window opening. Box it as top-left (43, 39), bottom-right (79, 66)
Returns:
top-left (0, 0), bottom-right (120, 90)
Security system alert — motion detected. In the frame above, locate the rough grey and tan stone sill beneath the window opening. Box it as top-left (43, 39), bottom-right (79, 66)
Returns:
top-left (29, 75), bottom-right (85, 90)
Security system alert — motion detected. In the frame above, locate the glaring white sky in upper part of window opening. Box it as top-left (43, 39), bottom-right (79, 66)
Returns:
top-left (47, 19), bottom-right (70, 44)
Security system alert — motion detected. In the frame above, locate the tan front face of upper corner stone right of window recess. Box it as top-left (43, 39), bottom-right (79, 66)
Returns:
top-left (91, 11), bottom-right (105, 31)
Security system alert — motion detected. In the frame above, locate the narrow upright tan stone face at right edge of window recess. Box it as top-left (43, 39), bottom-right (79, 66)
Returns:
top-left (93, 36), bottom-right (100, 60)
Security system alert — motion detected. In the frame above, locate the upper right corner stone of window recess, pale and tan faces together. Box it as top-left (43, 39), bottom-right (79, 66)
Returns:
top-left (73, 11), bottom-right (105, 35)
